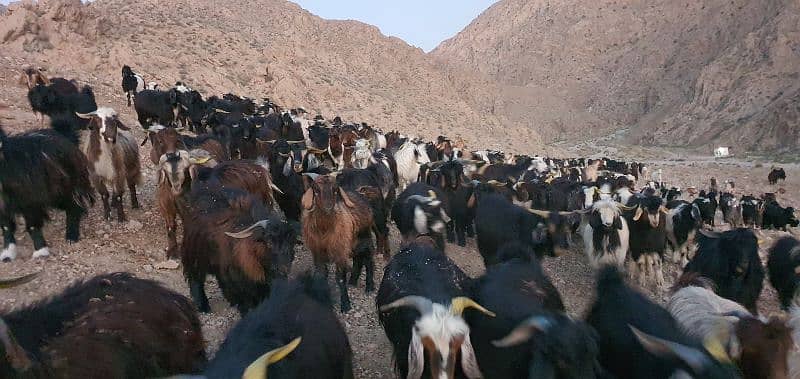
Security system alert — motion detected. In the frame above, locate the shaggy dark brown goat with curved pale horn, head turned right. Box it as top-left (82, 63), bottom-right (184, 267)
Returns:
top-left (181, 179), bottom-right (296, 314)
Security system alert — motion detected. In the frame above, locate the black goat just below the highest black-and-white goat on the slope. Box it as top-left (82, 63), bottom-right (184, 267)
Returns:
top-left (133, 88), bottom-right (180, 129)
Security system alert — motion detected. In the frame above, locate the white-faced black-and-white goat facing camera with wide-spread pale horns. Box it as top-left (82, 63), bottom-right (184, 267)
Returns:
top-left (582, 200), bottom-right (630, 270)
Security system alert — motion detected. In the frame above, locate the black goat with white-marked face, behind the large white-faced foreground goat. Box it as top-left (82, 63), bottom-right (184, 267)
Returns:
top-left (392, 183), bottom-right (450, 251)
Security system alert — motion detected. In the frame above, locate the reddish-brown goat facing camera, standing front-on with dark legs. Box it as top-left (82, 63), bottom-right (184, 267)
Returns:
top-left (302, 174), bottom-right (375, 313)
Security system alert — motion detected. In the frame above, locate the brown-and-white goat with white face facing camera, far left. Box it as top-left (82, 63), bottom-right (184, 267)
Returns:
top-left (77, 107), bottom-right (142, 222)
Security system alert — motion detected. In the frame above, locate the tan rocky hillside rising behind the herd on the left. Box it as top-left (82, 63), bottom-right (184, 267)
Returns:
top-left (0, 0), bottom-right (538, 151)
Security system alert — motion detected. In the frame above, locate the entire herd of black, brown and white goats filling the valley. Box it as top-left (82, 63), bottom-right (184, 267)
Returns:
top-left (0, 66), bottom-right (800, 379)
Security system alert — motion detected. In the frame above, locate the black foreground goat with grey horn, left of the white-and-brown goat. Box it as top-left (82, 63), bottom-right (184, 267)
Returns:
top-left (586, 266), bottom-right (739, 379)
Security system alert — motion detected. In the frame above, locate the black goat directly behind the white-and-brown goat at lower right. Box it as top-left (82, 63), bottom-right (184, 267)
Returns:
top-left (684, 229), bottom-right (764, 314)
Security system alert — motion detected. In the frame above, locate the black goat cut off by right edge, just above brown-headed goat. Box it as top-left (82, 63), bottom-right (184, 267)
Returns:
top-left (767, 237), bottom-right (800, 309)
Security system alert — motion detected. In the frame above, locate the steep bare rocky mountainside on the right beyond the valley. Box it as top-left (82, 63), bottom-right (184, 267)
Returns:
top-left (431, 0), bottom-right (800, 151)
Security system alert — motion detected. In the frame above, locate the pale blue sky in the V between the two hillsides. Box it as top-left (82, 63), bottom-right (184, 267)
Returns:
top-left (0, 0), bottom-right (497, 52)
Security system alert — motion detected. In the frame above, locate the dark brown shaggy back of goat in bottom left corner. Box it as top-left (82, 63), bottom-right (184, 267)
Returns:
top-left (0, 273), bottom-right (206, 378)
